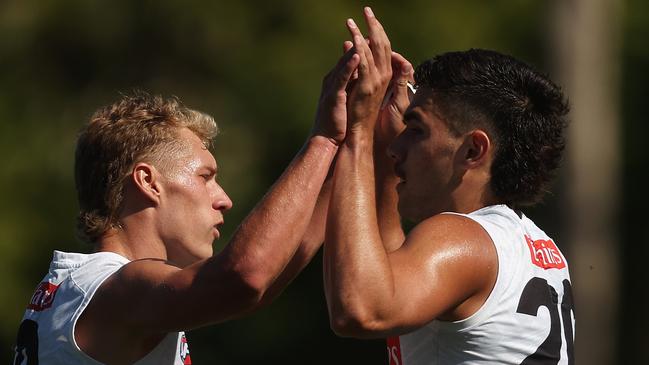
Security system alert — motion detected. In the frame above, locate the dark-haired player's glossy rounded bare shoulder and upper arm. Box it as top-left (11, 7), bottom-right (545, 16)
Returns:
top-left (390, 214), bottom-right (498, 325)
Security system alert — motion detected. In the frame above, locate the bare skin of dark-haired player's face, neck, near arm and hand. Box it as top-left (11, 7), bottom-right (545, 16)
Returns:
top-left (324, 8), bottom-right (497, 338)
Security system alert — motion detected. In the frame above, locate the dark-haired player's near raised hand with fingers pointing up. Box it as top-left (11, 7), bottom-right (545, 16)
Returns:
top-left (347, 7), bottom-right (392, 133)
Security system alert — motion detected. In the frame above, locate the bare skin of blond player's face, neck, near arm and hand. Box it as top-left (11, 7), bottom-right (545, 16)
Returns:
top-left (74, 48), bottom-right (359, 364)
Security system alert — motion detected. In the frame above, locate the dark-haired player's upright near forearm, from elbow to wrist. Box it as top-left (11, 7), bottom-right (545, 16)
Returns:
top-left (324, 136), bottom-right (394, 332)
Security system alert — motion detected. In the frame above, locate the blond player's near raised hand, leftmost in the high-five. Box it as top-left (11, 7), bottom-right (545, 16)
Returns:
top-left (312, 42), bottom-right (360, 145)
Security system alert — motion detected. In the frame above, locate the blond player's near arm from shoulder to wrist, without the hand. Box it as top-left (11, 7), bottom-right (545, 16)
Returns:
top-left (93, 136), bottom-right (337, 333)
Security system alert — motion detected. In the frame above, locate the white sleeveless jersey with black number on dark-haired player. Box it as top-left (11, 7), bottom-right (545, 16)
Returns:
top-left (388, 205), bottom-right (575, 365)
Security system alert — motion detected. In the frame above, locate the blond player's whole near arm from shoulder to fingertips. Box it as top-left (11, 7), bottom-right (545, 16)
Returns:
top-left (75, 40), bottom-right (358, 363)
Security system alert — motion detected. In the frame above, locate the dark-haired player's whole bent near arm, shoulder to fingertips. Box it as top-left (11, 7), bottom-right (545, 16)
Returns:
top-left (325, 8), bottom-right (497, 337)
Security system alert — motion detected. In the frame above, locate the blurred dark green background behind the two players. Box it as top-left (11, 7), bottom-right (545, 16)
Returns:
top-left (0, 0), bottom-right (649, 364)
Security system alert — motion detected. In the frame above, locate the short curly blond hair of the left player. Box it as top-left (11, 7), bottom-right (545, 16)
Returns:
top-left (74, 91), bottom-right (218, 243)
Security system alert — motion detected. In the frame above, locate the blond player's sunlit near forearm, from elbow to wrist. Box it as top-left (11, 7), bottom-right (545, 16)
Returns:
top-left (223, 136), bottom-right (337, 295)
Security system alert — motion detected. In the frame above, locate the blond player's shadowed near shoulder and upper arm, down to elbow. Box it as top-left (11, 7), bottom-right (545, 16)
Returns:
top-left (79, 255), bottom-right (258, 336)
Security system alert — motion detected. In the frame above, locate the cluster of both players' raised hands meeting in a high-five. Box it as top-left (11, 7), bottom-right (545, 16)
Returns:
top-left (313, 7), bottom-right (413, 146)
